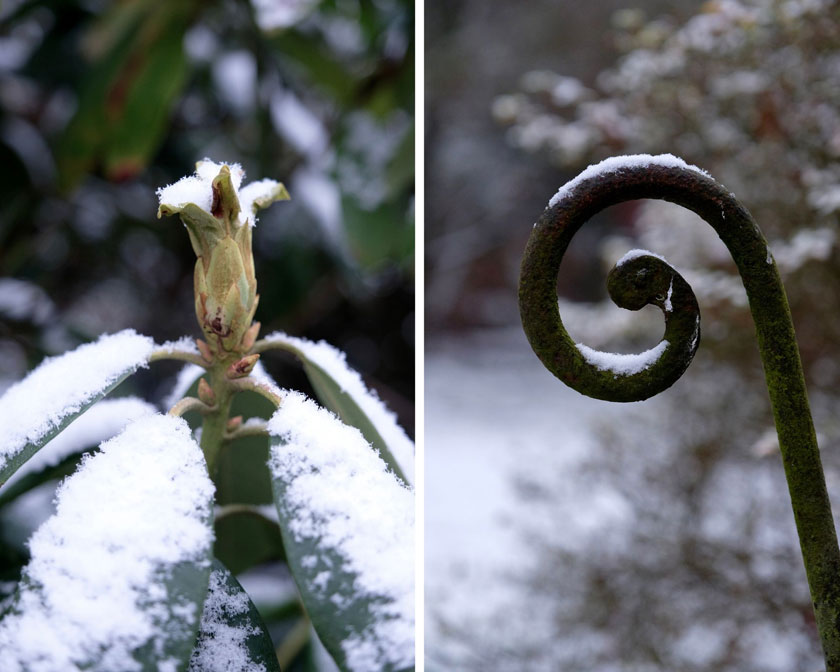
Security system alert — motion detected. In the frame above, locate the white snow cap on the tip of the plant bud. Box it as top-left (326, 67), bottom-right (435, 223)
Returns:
top-left (157, 159), bottom-right (282, 226)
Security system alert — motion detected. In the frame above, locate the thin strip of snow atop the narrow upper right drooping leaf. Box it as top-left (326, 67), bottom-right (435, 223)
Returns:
top-left (264, 331), bottom-right (414, 483)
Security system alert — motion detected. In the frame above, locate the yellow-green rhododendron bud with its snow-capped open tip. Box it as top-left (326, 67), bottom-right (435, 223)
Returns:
top-left (157, 160), bottom-right (289, 359)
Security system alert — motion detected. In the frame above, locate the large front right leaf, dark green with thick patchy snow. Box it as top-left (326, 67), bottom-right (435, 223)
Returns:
top-left (269, 392), bottom-right (414, 672)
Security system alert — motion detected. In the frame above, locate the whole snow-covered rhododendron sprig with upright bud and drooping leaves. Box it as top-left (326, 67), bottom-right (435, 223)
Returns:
top-left (0, 161), bottom-right (414, 672)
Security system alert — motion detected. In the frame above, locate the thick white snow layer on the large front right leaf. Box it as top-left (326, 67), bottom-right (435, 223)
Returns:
top-left (268, 392), bottom-right (414, 672)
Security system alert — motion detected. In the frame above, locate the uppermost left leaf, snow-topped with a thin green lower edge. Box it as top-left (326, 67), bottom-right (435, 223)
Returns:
top-left (0, 329), bottom-right (154, 484)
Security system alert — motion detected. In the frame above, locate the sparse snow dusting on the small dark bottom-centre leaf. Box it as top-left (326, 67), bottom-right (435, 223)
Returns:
top-left (189, 569), bottom-right (265, 672)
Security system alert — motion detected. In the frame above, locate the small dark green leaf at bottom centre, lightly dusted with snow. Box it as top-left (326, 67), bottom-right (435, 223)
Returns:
top-left (189, 559), bottom-right (280, 672)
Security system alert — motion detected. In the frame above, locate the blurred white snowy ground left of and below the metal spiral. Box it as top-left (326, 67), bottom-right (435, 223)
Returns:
top-left (425, 329), bottom-right (626, 670)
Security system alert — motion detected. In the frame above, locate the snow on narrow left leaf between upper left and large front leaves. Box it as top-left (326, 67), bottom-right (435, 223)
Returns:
top-left (7, 397), bottom-right (155, 484)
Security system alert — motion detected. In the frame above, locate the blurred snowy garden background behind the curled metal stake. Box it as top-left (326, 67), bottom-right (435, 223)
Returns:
top-left (425, 0), bottom-right (840, 672)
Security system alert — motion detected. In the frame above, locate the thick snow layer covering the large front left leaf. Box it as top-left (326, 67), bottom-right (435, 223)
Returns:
top-left (0, 415), bottom-right (213, 672)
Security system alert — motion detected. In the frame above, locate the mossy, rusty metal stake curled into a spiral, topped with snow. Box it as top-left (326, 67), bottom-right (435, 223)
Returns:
top-left (519, 155), bottom-right (840, 672)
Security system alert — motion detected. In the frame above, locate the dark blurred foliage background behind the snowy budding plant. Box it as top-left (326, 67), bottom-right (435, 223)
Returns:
top-left (0, 0), bottom-right (415, 669)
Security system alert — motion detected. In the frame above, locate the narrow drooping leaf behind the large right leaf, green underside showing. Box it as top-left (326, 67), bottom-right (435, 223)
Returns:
top-left (264, 331), bottom-right (414, 484)
